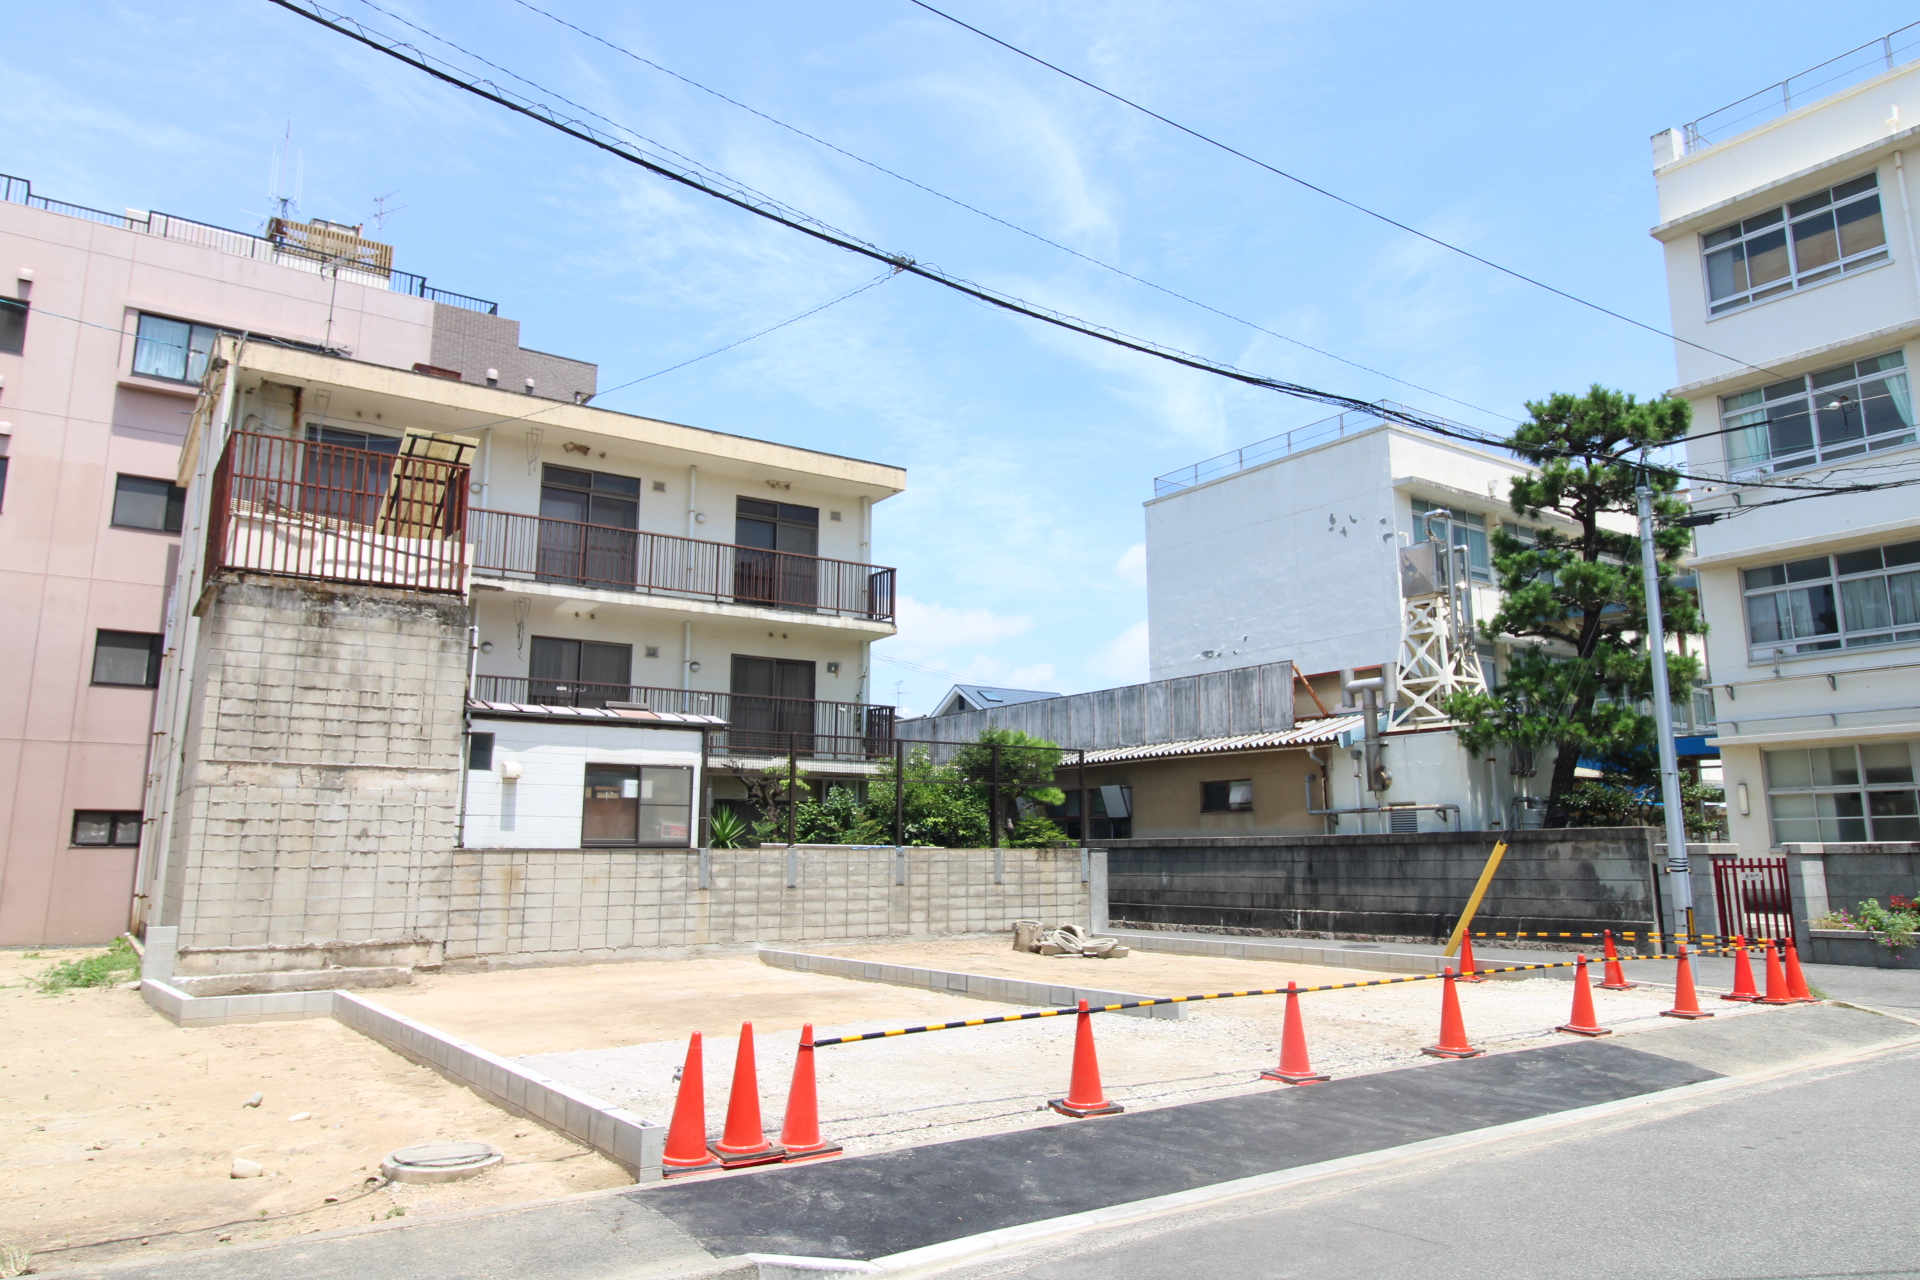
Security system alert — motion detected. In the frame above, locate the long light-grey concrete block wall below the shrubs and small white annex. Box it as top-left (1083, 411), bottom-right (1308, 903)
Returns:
top-left (445, 844), bottom-right (1104, 963)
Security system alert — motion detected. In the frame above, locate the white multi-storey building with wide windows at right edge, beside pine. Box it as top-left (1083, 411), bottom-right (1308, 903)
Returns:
top-left (1653, 29), bottom-right (1920, 852)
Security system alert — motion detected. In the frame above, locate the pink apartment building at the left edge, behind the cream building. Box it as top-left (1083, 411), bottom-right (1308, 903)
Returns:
top-left (0, 175), bottom-right (595, 946)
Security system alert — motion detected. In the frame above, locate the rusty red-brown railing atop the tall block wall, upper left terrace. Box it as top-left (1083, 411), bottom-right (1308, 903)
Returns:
top-left (207, 432), bottom-right (468, 595)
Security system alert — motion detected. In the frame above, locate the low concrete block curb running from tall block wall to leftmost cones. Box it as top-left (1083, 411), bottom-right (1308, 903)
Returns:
top-left (140, 979), bottom-right (666, 1182)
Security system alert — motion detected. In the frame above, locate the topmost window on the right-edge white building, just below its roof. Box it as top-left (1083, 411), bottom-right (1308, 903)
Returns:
top-left (1701, 173), bottom-right (1887, 315)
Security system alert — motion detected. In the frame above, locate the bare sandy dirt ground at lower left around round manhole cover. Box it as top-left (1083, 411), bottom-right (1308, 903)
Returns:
top-left (0, 948), bottom-right (630, 1272)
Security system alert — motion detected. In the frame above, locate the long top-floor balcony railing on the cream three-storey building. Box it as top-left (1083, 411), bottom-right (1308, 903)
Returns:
top-left (467, 509), bottom-right (893, 622)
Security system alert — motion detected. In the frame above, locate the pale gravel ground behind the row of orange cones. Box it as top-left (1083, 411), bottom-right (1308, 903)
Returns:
top-left (520, 940), bottom-right (1757, 1151)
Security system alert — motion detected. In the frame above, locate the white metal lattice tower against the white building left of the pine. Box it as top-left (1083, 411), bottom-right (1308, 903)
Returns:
top-left (1394, 510), bottom-right (1486, 727)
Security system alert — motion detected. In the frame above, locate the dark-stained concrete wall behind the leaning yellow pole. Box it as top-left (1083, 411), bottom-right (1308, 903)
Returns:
top-left (1108, 827), bottom-right (1657, 936)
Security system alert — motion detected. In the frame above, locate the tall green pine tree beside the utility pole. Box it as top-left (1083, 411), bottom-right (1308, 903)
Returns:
top-left (1446, 386), bottom-right (1705, 827)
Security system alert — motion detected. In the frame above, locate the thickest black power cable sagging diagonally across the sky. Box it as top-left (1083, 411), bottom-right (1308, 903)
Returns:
top-left (269, 0), bottom-right (1912, 510)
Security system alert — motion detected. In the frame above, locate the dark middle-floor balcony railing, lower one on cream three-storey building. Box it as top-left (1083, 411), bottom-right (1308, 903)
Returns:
top-left (474, 676), bottom-right (895, 760)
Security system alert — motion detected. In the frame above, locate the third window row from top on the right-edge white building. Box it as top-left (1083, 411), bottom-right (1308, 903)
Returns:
top-left (1741, 541), bottom-right (1920, 662)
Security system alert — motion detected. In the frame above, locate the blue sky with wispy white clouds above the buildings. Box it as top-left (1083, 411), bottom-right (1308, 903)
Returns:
top-left (0, 0), bottom-right (1912, 710)
